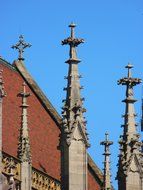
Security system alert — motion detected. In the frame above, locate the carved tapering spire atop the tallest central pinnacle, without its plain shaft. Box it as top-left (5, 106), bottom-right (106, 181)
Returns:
top-left (62, 24), bottom-right (88, 146)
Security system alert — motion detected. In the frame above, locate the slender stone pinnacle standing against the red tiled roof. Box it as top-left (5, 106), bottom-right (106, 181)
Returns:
top-left (18, 82), bottom-right (31, 190)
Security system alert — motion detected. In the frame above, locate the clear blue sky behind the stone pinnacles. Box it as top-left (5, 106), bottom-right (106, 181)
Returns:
top-left (0, 0), bottom-right (143, 189)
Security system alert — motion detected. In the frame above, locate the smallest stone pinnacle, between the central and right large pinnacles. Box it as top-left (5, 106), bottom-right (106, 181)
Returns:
top-left (100, 133), bottom-right (113, 190)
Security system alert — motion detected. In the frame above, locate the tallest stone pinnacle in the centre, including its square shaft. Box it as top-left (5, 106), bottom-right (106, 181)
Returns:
top-left (61, 24), bottom-right (89, 190)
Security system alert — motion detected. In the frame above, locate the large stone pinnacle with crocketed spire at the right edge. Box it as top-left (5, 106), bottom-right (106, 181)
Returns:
top-left (117, 64), bottom-right (143, 190)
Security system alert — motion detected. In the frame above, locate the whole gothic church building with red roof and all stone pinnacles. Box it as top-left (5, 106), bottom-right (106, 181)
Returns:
top-left (0, 23), bottom-right (143, 190)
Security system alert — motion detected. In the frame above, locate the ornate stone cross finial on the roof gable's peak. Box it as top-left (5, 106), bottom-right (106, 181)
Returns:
top-left (12, 35), bottom-right (31, 60)
